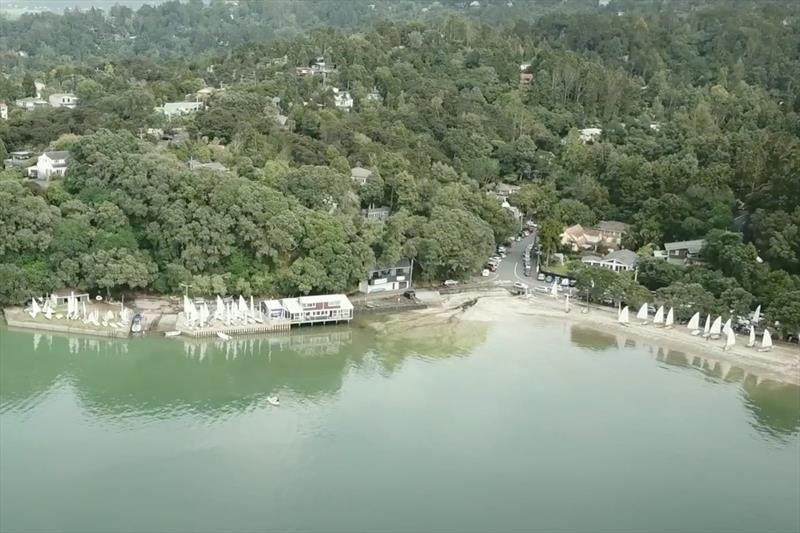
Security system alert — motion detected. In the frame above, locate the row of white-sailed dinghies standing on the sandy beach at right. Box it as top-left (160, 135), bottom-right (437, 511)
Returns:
top-left (617, 303), bottom-right (772, 351)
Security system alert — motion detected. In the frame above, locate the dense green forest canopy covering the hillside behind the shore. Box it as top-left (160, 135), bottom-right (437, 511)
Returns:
top-left (0, 0), bottom-right (800, 331)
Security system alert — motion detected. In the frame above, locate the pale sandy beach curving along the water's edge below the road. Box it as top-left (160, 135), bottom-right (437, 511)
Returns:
top-left (376, 289), bottom-right (800, 384)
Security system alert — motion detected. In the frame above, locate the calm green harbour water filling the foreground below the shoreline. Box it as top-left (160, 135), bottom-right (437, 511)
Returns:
top-left (0, 319), bottom-right (800, 533)
